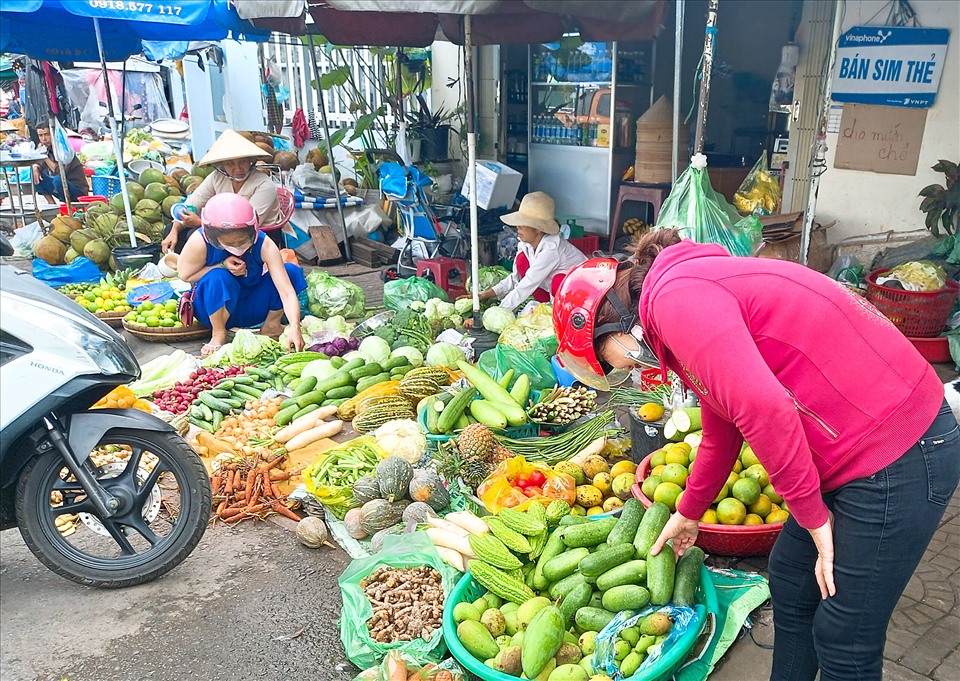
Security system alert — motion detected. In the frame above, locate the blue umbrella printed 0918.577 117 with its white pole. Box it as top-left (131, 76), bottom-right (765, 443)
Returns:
top-left (0, 0), bottom-right (264, 246)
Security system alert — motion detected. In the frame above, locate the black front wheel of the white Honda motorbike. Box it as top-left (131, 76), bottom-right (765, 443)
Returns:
top-left (17, 429), bottom-right (211, 588)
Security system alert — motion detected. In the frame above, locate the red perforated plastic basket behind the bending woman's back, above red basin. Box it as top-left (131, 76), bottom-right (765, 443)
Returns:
top-left (867, 269), bottom-right (960, 338)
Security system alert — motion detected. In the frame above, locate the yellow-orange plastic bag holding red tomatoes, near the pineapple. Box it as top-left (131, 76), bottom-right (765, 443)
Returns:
top-left (477, 456), bottom-right (577, 513)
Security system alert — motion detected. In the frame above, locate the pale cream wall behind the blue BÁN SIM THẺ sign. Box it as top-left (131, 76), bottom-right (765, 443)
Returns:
top-left (817, 0), bottom-right (960, 243)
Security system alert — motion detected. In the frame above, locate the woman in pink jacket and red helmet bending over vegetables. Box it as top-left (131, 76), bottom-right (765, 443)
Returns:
top-left (554, 230), bottom-right (960, 681)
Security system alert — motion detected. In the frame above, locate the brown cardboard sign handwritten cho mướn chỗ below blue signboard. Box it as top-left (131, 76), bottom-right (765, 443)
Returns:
top-left (833, 104), bottom-right (927, 175)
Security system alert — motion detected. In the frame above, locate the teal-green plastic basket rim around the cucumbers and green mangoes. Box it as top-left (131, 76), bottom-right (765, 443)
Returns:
top-left (443, 566), bottom-right (720, 681)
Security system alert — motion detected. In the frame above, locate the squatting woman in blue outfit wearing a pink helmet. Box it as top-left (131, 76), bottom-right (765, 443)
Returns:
top-left (177, 193), bottom-right (307, 356)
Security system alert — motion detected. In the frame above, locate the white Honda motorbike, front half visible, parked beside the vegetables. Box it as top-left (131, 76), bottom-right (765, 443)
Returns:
top-left (0, 265), bottom-right (211, 588)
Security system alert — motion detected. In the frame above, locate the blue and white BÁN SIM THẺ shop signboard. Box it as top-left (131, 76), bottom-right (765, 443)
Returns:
top-left (832, 26), bottom-right (950, 109)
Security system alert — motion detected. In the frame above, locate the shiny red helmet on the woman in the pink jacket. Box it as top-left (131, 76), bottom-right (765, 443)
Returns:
top-left (553, 258), bottom-right (652, 390)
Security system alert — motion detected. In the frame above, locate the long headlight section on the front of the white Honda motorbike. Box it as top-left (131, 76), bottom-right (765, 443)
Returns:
top-left (4, 296), bottom-right (140, 378)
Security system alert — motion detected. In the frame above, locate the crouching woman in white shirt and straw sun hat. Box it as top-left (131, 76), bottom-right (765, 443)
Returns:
top-left (480, 192), bottom-right (587, 310)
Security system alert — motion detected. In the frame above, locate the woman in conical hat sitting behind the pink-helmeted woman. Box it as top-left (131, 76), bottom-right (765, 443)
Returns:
top-left (161, 130), bottom-right (281, 253)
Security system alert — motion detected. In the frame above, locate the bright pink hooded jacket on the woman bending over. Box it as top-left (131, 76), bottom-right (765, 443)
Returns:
top-left (640, 241), bottom-right (943, 528)
